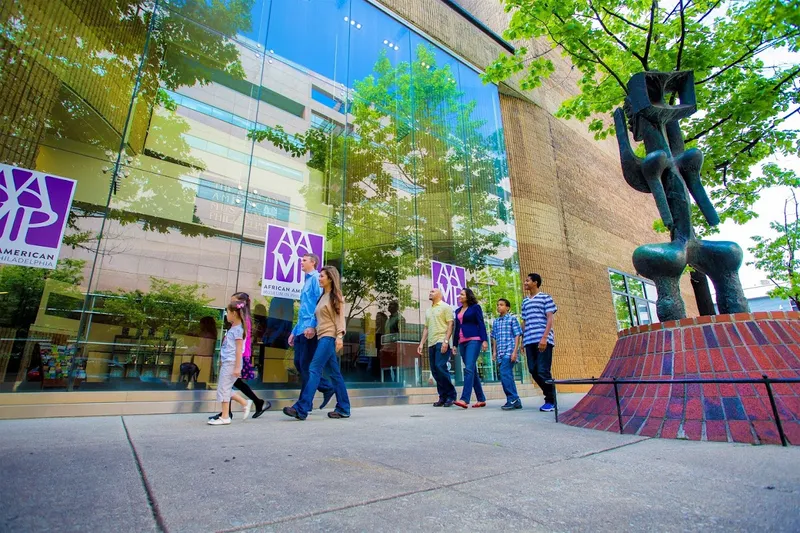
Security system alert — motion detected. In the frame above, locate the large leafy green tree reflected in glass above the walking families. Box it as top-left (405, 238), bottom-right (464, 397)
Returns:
top-left (250, 45), bottom-right (506, 316)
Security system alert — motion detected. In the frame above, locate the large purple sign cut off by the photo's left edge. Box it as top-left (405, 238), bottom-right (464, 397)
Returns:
top-left (0, 164), bottom-right (77, 269)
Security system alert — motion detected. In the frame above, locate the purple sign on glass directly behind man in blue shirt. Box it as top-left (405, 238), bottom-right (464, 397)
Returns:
top-left (261, 224), bottom-right (325, 300)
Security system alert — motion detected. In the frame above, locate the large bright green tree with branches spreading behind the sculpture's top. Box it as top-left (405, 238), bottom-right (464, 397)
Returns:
top-left (485, 0), bottom-right (800, 234)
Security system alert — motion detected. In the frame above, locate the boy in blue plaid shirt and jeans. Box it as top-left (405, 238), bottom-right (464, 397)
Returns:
top-left (492, 298), bottom-right (522, 411)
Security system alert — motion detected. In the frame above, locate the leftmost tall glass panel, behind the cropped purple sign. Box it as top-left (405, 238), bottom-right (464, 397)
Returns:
top-left (0, 0), bottom-right (149, 392)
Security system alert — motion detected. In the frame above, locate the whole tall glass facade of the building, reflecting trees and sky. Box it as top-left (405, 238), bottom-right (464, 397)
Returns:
top-left (0, 0), bottom-right (521, 392)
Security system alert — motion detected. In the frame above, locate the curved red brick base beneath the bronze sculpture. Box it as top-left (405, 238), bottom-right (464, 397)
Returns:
top-left (559, 312), bottom-right (800, 445)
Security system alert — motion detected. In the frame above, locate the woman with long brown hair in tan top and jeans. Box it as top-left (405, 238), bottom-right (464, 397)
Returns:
top-left (283, 266), bottom-right (350, 420)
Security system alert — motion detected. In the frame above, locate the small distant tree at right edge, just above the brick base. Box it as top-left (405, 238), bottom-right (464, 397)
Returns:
top-left (750, 189), bottom-right (800, 309)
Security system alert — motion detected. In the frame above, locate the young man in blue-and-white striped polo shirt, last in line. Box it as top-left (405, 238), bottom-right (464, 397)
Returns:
top-left (522, 274), bottom-right (558, 412)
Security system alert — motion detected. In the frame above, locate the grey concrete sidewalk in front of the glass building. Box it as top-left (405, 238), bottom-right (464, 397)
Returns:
top-left (0, 394), bottom-right (800, 533)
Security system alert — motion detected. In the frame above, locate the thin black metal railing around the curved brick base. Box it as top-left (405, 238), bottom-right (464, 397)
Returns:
top-left (547, 374), bottom-right (800, 446)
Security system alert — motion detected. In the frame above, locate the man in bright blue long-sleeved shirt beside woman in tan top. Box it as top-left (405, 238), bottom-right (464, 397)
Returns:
top-left (289, 254), bottom-right (333, 409)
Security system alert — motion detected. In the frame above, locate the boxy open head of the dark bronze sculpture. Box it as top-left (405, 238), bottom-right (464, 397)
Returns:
top-left (625, 71), bottom-right (697, 141)
